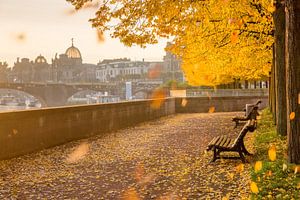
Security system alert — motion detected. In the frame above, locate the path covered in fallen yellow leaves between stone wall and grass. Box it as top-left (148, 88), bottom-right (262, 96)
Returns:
top-left (0, 113), bottom-right (252, 199)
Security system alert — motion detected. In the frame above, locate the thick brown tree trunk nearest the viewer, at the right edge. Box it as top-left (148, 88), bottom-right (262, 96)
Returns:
top-left (285, 0), bottom-right (300, 164)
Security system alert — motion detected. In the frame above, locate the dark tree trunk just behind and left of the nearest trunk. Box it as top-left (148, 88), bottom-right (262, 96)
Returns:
top-left (274, 3), bottom-right (287, 135)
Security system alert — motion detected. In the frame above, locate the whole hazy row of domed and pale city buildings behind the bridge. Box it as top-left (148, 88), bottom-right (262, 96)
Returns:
top-left (0, 39), bottom-right (184, 83)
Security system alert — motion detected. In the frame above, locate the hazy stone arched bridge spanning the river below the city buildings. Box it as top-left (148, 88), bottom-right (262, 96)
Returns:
top-left (0, 82), bottom-right (160, 107)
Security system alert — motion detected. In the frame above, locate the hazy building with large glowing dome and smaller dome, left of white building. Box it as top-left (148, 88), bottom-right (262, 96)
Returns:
top-left (8, 39), bottom-right (97, 83)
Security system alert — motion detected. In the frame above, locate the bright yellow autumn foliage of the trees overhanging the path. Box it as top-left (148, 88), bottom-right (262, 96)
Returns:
top-left (67, 0), bottom-right (274, 86)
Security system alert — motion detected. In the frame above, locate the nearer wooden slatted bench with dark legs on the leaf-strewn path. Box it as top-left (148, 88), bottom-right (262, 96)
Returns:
top-left (207, 119), bottom-right (256, 163)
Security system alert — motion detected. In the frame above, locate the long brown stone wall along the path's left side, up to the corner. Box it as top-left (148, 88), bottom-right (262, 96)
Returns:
top-left (0, 99), bottom-right (175, 159)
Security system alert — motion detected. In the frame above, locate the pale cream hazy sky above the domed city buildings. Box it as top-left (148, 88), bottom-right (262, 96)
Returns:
top-left (0, 0), bottom-right (166, 67)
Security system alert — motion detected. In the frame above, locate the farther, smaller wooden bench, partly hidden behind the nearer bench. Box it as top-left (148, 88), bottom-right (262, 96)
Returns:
top-left (232, 100), bottom-right (261, 128)
